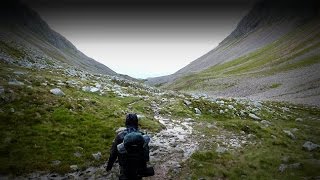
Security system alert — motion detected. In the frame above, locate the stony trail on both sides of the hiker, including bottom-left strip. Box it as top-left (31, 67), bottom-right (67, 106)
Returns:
top-left (12, 102), bottom-right (198, 180)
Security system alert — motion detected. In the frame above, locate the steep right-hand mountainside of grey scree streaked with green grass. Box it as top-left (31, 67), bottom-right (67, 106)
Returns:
top-left (149, 1), bottom-right (320, 105)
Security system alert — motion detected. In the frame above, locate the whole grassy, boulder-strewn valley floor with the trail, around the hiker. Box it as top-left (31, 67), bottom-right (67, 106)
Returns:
top-left (0, 64), bottom-right (320, 179)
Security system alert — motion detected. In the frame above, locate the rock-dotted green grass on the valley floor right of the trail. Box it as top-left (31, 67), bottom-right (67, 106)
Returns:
top-left (161, 96), bottom-right (320, 179)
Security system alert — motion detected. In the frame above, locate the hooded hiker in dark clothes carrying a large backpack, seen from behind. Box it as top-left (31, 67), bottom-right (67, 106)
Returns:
top-left (106, 114), bottom-right (154, 180)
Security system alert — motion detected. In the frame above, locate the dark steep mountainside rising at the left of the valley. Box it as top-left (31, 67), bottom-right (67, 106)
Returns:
top-left (0, 0), bottom-right (116, 75)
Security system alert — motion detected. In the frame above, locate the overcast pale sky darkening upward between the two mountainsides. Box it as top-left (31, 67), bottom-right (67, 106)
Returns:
top-left (25, 0), bottom-right (252, 78)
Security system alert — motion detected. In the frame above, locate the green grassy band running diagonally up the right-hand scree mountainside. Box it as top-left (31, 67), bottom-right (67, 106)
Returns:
top-left (167, 20), bottom-right (320, 91)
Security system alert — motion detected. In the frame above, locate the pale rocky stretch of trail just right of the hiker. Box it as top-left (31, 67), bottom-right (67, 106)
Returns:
top-left (145, 102), bottom-right (198, 180)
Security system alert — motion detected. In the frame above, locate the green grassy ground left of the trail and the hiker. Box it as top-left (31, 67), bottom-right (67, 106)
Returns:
top-left (0, 63), bottom-right (161, 174)
